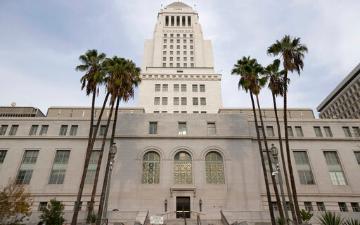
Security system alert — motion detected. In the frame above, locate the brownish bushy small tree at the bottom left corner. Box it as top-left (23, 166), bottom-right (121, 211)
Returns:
top-left (0, 181), bottom-right (32, 225)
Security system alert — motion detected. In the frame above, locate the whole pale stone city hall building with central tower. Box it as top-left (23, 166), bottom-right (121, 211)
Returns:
top-left (0, 2), bottom-right (360, 225)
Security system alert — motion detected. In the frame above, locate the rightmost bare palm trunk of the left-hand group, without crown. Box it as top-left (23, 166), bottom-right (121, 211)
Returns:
top-left (96, 97), bottom-right (120, 225)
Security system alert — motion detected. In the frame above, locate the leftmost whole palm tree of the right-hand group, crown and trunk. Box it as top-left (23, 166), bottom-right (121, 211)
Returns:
top-left (231, 56), bottom-right (275, 225)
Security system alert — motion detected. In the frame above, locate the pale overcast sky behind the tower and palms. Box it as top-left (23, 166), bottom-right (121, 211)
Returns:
top-left (0, 0), bottom-right (360, 113)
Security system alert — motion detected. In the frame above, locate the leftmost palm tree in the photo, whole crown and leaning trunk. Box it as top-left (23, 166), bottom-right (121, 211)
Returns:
top-left (71, 49), bottom-right (106, 225)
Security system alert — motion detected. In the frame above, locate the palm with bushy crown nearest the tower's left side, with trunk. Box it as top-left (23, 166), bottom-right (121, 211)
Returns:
top-left (97, 56), bottom-right (141, 225)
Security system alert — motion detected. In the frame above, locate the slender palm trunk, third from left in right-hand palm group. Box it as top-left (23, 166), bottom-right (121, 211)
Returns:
top-left (272, 92), bottom-right (297, 223)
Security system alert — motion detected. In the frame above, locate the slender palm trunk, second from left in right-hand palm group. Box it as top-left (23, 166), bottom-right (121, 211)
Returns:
top-left (255, 95), bottom-right (285, 221)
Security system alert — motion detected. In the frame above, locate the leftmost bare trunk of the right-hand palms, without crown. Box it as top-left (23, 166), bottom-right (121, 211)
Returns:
top-left (250, 91), bottom-right (276, 225)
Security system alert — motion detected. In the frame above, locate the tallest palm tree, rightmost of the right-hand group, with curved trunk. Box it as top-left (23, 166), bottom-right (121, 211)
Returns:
top-left (267, 35), bottom-right (308, 224)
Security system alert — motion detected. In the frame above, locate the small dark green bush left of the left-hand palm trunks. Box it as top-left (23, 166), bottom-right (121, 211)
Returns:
top-left (40, 199), bottom-right (65, 225)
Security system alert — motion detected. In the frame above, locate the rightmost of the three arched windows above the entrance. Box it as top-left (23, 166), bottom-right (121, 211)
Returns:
top-left (205, 152), bottom-right (225, 184)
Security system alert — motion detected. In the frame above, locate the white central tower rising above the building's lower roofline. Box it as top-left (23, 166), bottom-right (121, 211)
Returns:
top-left (139, 2), bottom-right (222, 113)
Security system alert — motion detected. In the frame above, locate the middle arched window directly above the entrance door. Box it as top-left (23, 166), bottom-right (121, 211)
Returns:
top-left (174, 152), bottom-right (192, 184)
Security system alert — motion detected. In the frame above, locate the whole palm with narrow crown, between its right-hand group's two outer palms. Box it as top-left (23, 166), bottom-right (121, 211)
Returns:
top-left (264, 59), bottom-right (296, 220)
